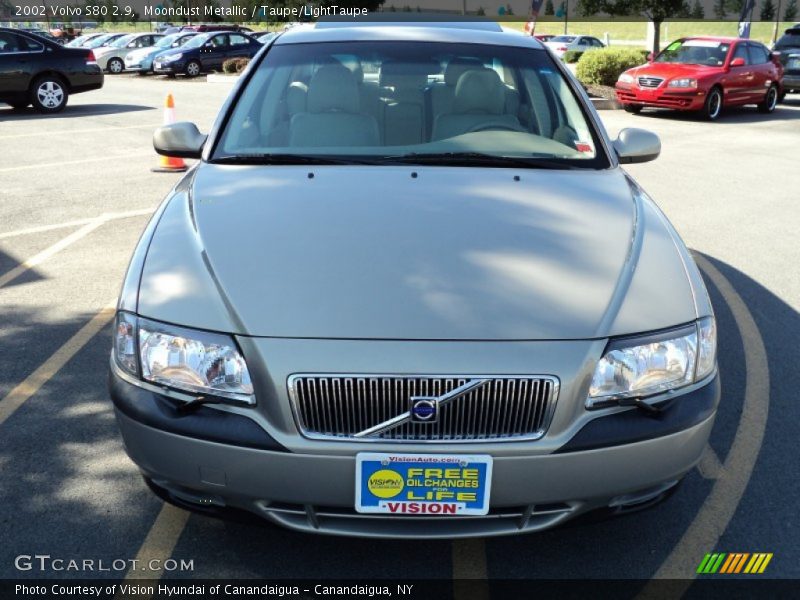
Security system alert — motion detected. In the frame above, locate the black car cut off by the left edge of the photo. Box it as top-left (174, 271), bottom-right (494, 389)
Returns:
top-left (0, 28), bottom-right (103, 113)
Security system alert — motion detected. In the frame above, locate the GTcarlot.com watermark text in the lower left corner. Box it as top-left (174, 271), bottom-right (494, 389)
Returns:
top-left (14, 554), bottom-right (194, 573)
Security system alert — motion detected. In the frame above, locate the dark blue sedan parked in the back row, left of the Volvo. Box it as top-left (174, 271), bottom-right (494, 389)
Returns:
top-left (153, 32), bottom-right (261, 77)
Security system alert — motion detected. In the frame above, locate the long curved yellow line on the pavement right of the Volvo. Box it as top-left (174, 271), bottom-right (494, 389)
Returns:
top-left (638, 255), bottom-right (769, 599)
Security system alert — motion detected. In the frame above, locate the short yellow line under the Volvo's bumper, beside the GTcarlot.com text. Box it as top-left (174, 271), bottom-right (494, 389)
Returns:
top-left (114, 503), bottom-right (189, 600)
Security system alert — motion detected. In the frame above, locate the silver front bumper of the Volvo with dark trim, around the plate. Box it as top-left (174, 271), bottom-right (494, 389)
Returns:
top-left (110, 372), bottom-right (720, 538)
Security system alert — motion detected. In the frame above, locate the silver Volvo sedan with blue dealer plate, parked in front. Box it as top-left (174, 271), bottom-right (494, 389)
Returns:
top-left (110, 23), bottom-right (720, 537)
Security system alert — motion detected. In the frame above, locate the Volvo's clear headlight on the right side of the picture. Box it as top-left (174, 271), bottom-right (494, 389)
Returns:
top-left (586, 317), bottom-right (717, 408)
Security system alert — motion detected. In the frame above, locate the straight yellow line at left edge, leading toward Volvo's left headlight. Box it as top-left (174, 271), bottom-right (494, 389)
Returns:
top-left (0, 299), bottom-right (117, 425)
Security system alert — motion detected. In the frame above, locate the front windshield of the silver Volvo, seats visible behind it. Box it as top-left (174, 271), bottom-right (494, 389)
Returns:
top-left (213, 42), bottom-right (608, 168)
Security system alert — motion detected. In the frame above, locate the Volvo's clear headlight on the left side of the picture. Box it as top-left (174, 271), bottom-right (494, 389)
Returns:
top-left (113, 312), bottom-right (255, 404)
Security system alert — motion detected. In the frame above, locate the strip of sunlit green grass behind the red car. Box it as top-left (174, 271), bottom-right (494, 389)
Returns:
top-left (503, 21), bottom-right (793, 45)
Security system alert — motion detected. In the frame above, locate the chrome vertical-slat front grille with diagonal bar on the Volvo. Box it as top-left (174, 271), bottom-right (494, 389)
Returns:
top-left (289, 375), bottom-right (558, 442)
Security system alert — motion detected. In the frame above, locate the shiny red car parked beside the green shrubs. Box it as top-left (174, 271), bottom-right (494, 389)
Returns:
top-left (616, 37), bottom-right (783, 121)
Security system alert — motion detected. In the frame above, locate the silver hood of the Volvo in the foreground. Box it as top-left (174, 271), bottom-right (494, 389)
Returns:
top-left (138, 163), bottom-right (696, 340)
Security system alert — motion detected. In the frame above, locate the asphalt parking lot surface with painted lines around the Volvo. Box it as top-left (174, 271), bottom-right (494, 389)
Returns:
top-left (0, 76), bottom-right (800, 598)
